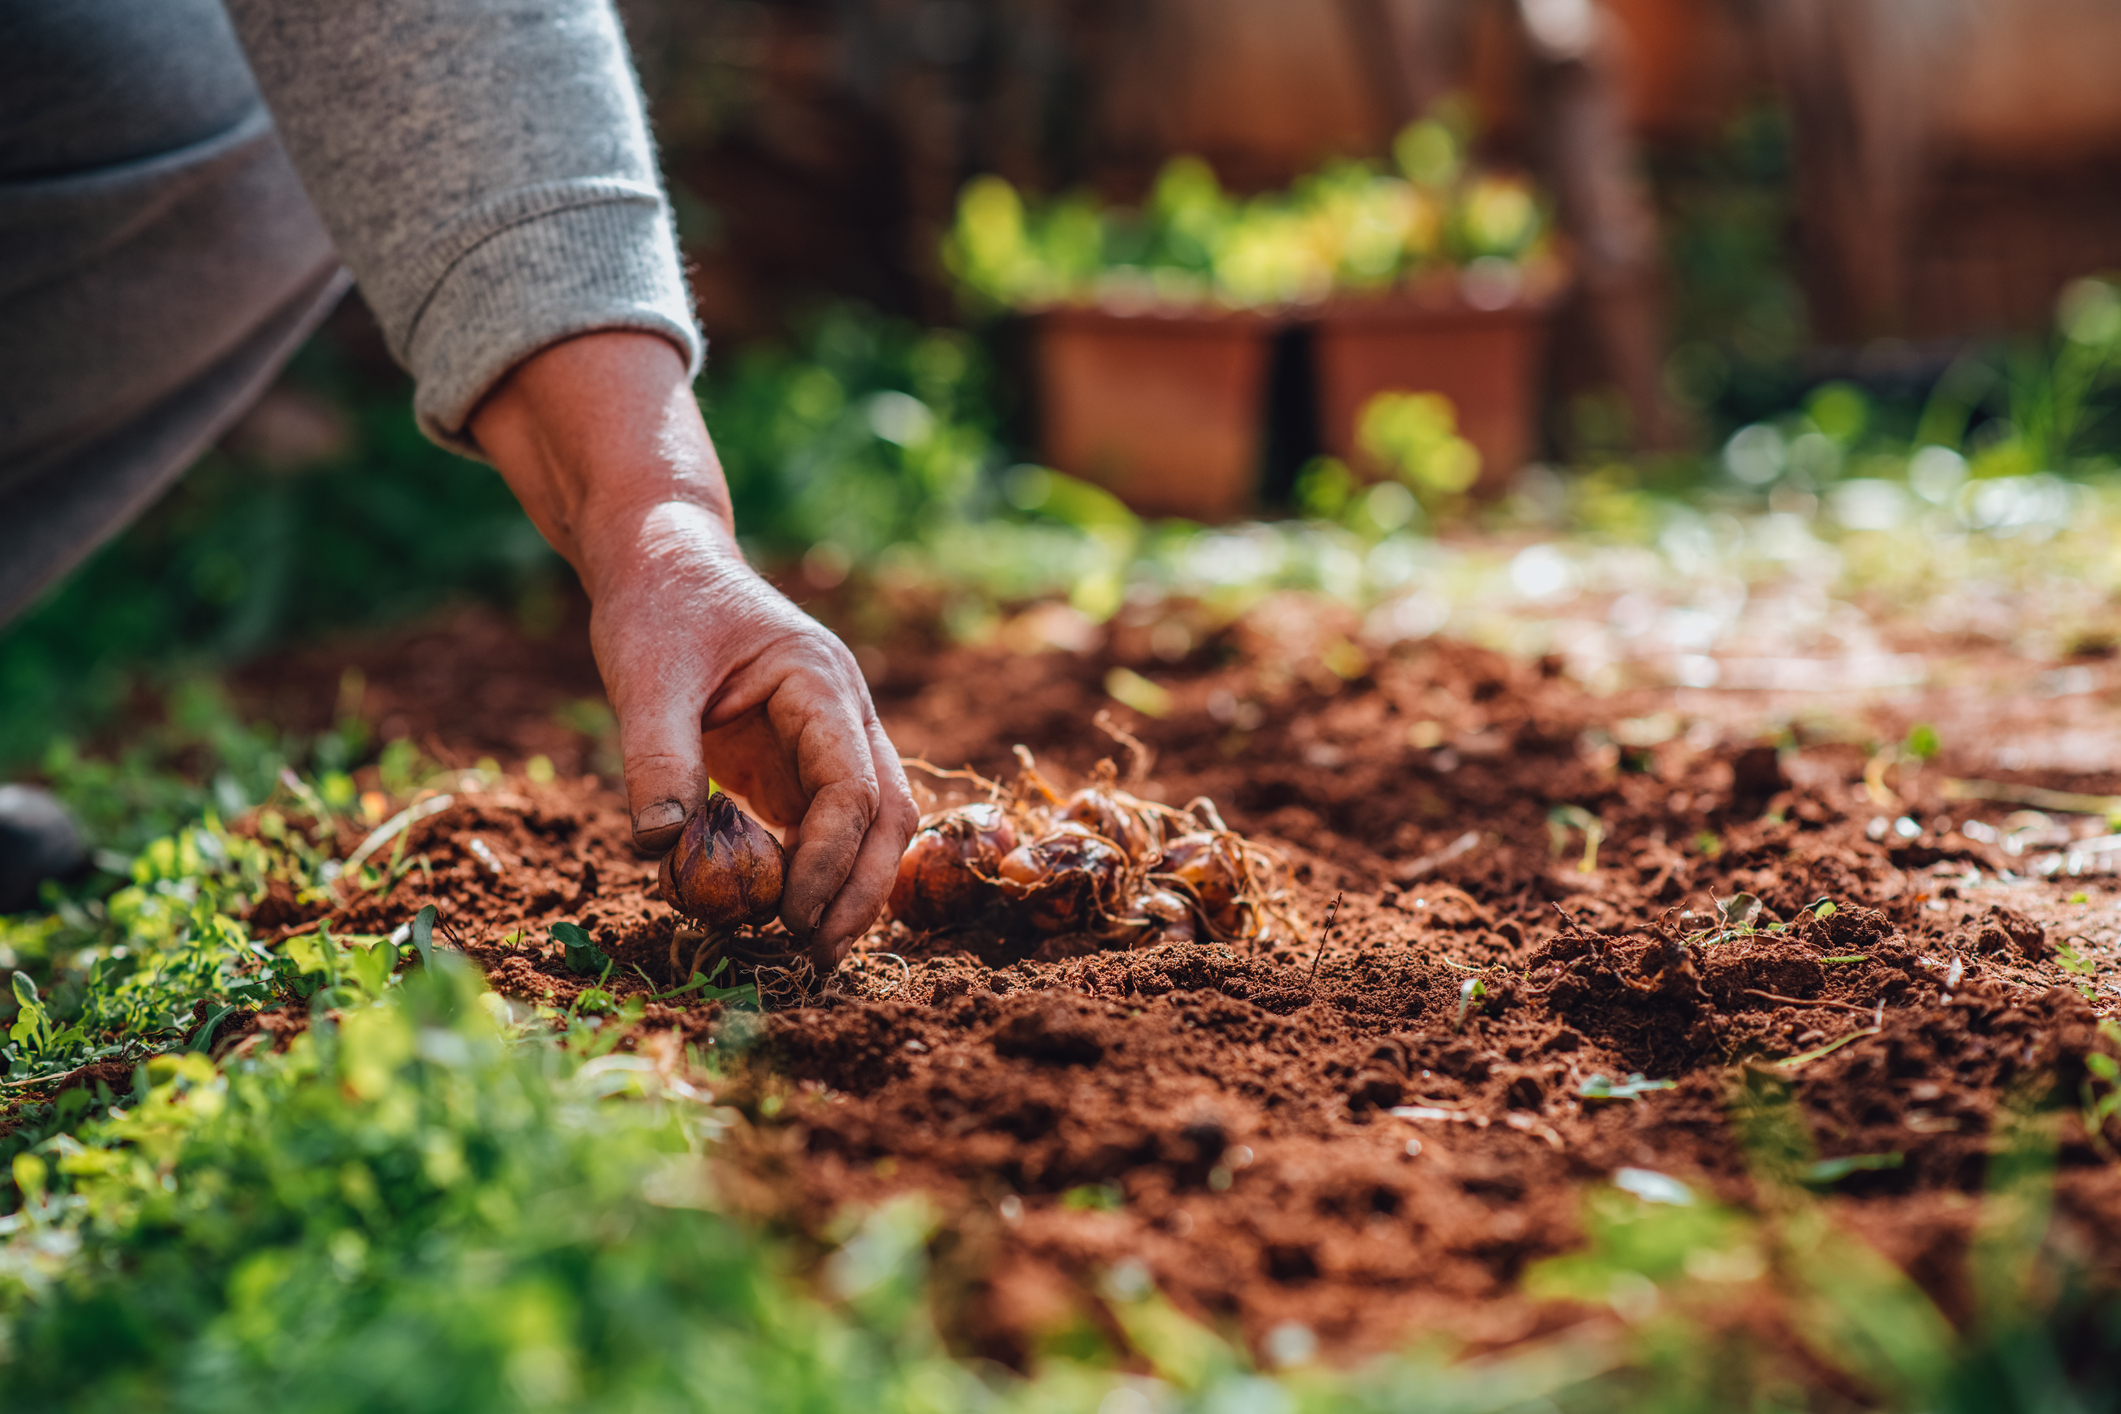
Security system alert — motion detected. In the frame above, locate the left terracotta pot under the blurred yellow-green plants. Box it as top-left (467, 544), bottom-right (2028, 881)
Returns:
top-left (1037, 310), bottom-right (1275, 522)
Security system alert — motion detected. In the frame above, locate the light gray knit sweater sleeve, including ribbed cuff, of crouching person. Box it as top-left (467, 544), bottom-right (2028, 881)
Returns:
top-left (229, 0), bottom-right (704, 454)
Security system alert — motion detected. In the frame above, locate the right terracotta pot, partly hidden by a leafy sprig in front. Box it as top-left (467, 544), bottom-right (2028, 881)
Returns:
top-left (1313, 297), bottom-right (1550, 494)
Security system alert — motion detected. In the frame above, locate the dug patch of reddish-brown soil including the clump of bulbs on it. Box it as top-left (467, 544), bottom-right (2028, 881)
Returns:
top-left (202, 610), bottom-right (2121, 1365)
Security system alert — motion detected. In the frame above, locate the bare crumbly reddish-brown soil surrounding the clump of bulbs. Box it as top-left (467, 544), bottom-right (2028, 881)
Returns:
top-left (228, 604), bottom-right (2121, 1361)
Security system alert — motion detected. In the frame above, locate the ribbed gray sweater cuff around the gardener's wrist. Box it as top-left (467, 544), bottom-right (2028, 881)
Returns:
top-left (403, 182), bottom-right (706, 456)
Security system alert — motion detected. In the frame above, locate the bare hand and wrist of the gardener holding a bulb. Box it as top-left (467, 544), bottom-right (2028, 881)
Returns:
top-left (471, 331), bottom-right (918, 971)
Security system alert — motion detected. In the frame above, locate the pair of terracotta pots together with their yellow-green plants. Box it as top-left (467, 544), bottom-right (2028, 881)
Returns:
top-left (944, 119), bottom-right (1559, 519)
